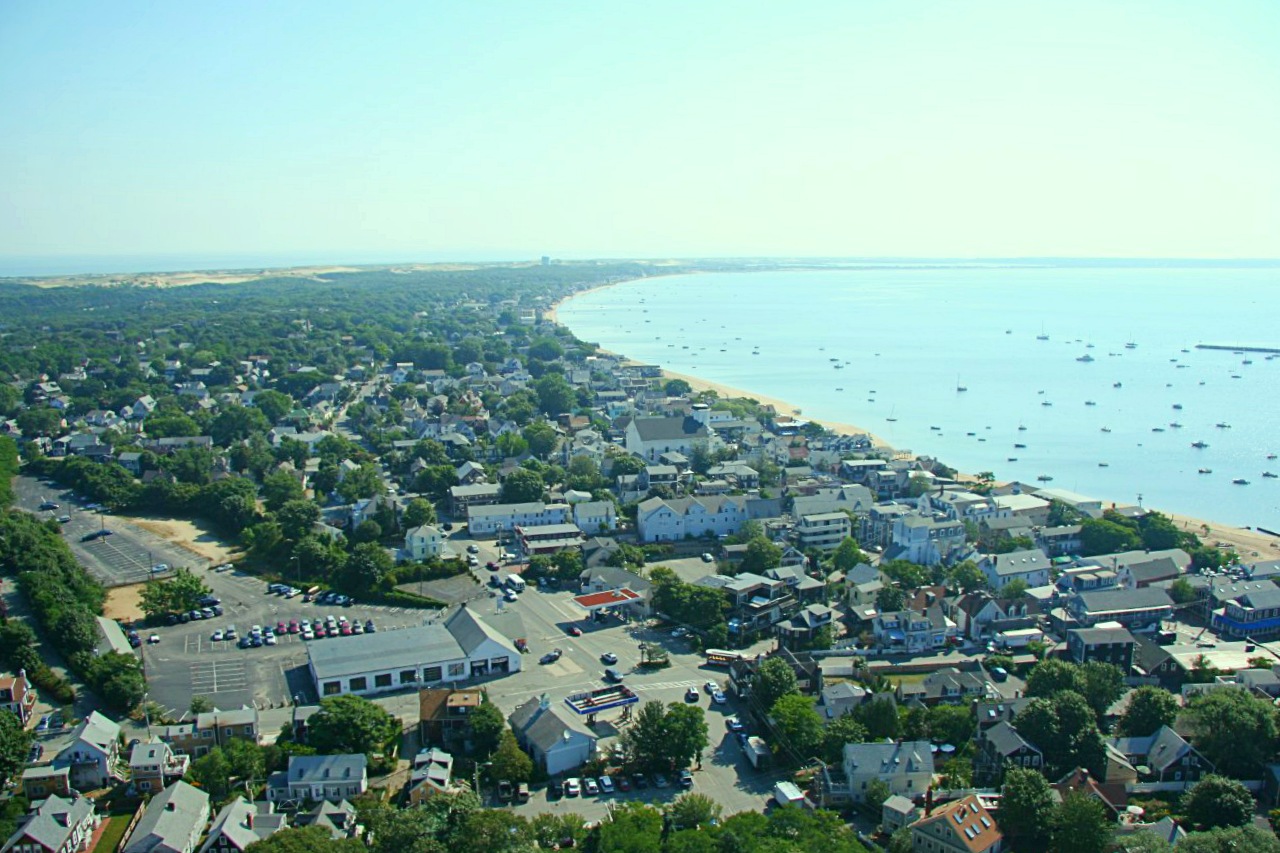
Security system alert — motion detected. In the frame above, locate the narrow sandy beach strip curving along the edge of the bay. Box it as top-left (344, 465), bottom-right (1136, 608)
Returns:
top-left (543, 277), bottom-right (1280, 550)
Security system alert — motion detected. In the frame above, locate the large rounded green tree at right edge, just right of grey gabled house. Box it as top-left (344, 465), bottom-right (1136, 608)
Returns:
top-left (1188, 689), bottom-right (1276, 779)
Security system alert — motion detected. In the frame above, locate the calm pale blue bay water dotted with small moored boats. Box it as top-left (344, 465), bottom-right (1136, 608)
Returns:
top-left (558, 265), bottom-right (1280, 530)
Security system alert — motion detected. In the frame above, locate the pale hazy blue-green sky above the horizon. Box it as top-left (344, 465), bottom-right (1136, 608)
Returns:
top-left (0, 0), bottom-right (1280, 267)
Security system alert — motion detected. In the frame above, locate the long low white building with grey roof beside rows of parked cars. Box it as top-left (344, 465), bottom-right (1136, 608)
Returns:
top-left (307, 605), bottom-right (521, 697)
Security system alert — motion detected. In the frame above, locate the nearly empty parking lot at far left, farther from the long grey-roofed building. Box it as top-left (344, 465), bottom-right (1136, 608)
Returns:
top-left (13, 475), bottom-right (197, 587)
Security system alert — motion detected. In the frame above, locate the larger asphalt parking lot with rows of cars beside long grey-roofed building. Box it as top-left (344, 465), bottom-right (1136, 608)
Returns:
top-left (142, 569), bottom-right (445, 715)
